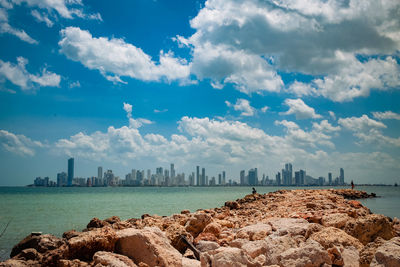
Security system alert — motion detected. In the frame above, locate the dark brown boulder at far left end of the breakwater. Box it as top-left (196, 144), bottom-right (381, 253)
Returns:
top-left (10, 234), bottom-right (64, 258)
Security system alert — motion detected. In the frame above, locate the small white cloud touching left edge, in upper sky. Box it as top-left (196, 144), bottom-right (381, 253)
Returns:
top-left (0, 57), bottom-right (61, 90)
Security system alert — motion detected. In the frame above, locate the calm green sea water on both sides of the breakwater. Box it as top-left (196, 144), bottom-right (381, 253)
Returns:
top-left (0, 186), bottom-right (400, 261)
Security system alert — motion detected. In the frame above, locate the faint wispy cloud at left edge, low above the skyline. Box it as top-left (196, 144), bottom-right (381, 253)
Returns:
top-left (0, 130), bottom-right (44, 156)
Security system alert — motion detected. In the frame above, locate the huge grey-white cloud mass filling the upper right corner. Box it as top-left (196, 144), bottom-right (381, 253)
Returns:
top-left (184, 0), bottom-right (400, 99)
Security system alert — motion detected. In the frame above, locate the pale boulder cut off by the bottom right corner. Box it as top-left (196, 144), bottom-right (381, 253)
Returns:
top-left (371, 237), bottom-right (400, 267)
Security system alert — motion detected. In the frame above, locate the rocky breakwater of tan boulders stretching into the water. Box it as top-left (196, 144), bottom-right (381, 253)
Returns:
top-left (0, 189), bottom-right (400, 267)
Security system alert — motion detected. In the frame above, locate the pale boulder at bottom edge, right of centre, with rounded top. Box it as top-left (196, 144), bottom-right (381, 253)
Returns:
top-left (280, 240), bottom-right (332, 267)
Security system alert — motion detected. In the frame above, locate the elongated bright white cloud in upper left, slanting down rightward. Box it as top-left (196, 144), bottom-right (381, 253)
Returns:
top-left (58, 27), bottom-right (190, 82)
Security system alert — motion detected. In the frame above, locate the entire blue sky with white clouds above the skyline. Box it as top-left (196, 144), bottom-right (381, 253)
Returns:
top-left (0, 0), bottom-right (400, 186)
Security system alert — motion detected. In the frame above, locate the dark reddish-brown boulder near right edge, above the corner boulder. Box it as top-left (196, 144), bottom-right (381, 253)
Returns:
top-left (344, 214), bottom-right (394, 245)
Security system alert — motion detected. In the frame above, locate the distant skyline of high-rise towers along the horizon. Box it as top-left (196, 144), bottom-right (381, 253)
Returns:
top-left (33, 158), bottom-right (357, 187)
